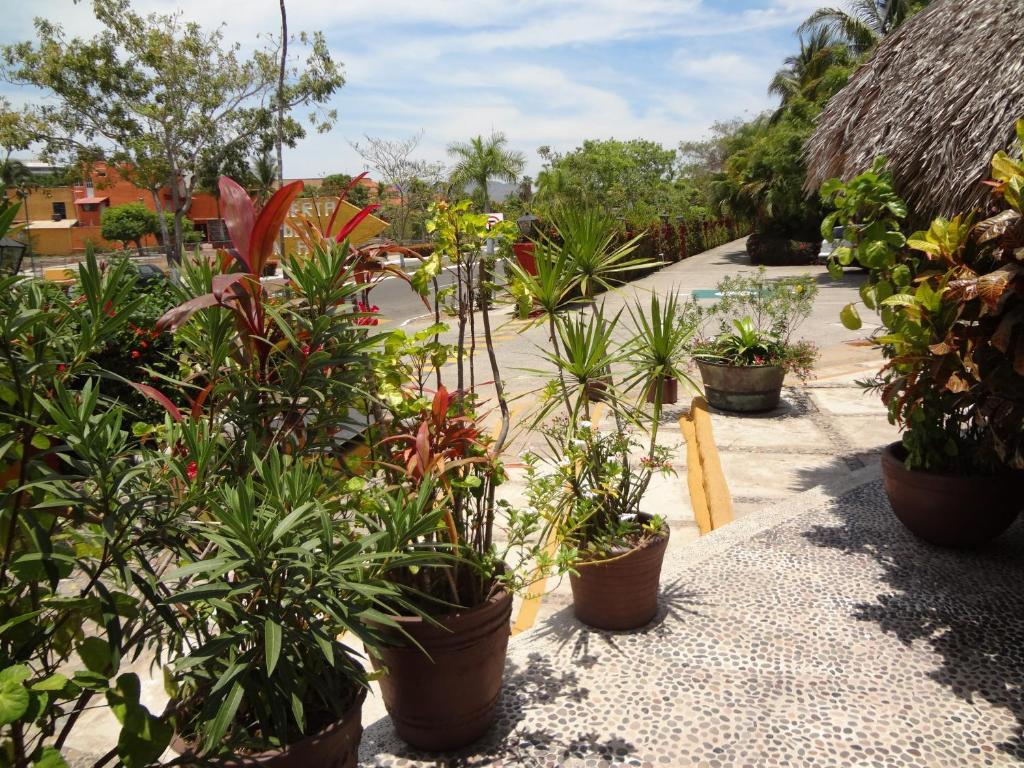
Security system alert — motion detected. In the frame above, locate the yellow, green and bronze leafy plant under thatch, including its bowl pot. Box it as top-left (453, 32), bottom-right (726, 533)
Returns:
top-left (822, 138), bottom-right (1024, 547)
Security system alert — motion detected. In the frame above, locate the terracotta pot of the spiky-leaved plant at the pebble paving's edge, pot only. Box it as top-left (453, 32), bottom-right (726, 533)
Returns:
top-left (569, 515), bottom-right (669, 630)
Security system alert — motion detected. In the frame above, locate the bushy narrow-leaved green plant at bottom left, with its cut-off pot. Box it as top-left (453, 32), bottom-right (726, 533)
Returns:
top-left (165, 448), bottom-right (437, 768)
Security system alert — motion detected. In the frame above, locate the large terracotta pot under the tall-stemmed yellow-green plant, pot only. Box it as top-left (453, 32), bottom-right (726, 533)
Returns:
top-left (371, 591), bottom-right (512, 752)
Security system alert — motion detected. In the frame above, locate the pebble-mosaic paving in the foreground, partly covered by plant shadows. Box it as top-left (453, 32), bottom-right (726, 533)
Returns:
top-left (360, 480), bottom-right (1024, 768)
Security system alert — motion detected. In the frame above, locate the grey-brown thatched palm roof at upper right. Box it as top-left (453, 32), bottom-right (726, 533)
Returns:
top-left (806, 0), bottom-right (1024, 219)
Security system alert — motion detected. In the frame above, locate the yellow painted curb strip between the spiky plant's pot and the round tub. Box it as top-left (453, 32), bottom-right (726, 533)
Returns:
top-left (679, 396), bottom-right (735, 535)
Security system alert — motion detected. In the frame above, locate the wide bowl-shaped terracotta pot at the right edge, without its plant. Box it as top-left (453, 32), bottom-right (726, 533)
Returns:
top-left (882, 442), bottom-right (1024, 549)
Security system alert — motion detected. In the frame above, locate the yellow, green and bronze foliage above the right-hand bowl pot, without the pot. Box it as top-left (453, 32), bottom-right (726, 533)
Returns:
top-left (823, 121), bottom-right (1024, 473)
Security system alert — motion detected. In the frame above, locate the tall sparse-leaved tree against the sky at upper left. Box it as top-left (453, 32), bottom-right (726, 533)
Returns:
top-left (0, 0), bottom-right (344, 263)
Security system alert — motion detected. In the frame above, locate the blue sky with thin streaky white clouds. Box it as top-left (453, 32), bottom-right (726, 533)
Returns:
top-left (0, 0), bottom-right (823, 177)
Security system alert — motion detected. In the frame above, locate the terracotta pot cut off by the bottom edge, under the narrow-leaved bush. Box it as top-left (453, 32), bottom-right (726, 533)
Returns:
top-left (171, 689), bottom-right (367, 768)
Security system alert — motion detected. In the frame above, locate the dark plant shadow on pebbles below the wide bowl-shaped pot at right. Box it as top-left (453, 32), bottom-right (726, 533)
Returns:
top-left (804, 495), bottom-right (1024, 759)
